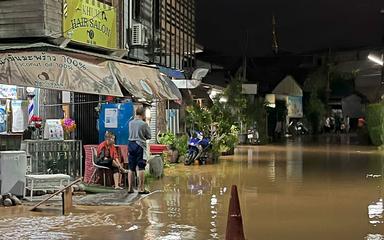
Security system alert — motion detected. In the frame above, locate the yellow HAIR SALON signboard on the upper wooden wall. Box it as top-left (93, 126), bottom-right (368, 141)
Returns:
top-left (63, 0), bottom-right (116, 48)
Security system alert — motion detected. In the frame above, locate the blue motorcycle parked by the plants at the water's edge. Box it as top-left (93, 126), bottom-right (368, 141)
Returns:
top-left (184, 131), bottom-right (212, 165)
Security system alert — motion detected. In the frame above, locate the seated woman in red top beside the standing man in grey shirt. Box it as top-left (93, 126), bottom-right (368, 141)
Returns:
top-left (96, 132), bottom-right (128, 189)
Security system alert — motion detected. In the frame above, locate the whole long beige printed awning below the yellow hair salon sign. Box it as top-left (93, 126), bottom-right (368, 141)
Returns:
top-left (0, 43), bottom-right (181, 101)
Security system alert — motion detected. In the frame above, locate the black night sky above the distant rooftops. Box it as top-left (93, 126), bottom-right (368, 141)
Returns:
top-left (196, 0), bottom-right (384, 56)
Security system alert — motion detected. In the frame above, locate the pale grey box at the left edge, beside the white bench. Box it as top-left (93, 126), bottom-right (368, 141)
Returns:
top-left (0, 151), bottom-right (27, 196)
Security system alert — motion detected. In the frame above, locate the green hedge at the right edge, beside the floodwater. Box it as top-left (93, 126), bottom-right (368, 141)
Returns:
top-left (366, 102), bottom-right (384, 146)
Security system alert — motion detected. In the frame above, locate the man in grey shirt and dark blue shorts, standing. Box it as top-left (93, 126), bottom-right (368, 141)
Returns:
top-left (128, 106), bottom-right (151, 194)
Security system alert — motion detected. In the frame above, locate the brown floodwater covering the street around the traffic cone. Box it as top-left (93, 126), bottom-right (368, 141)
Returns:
top-left (0, 142), bottom-right (384, 240)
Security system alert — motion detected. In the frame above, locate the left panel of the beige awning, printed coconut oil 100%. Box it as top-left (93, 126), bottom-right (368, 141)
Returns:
top-left (0, 52), bottom-right (122, 96)
